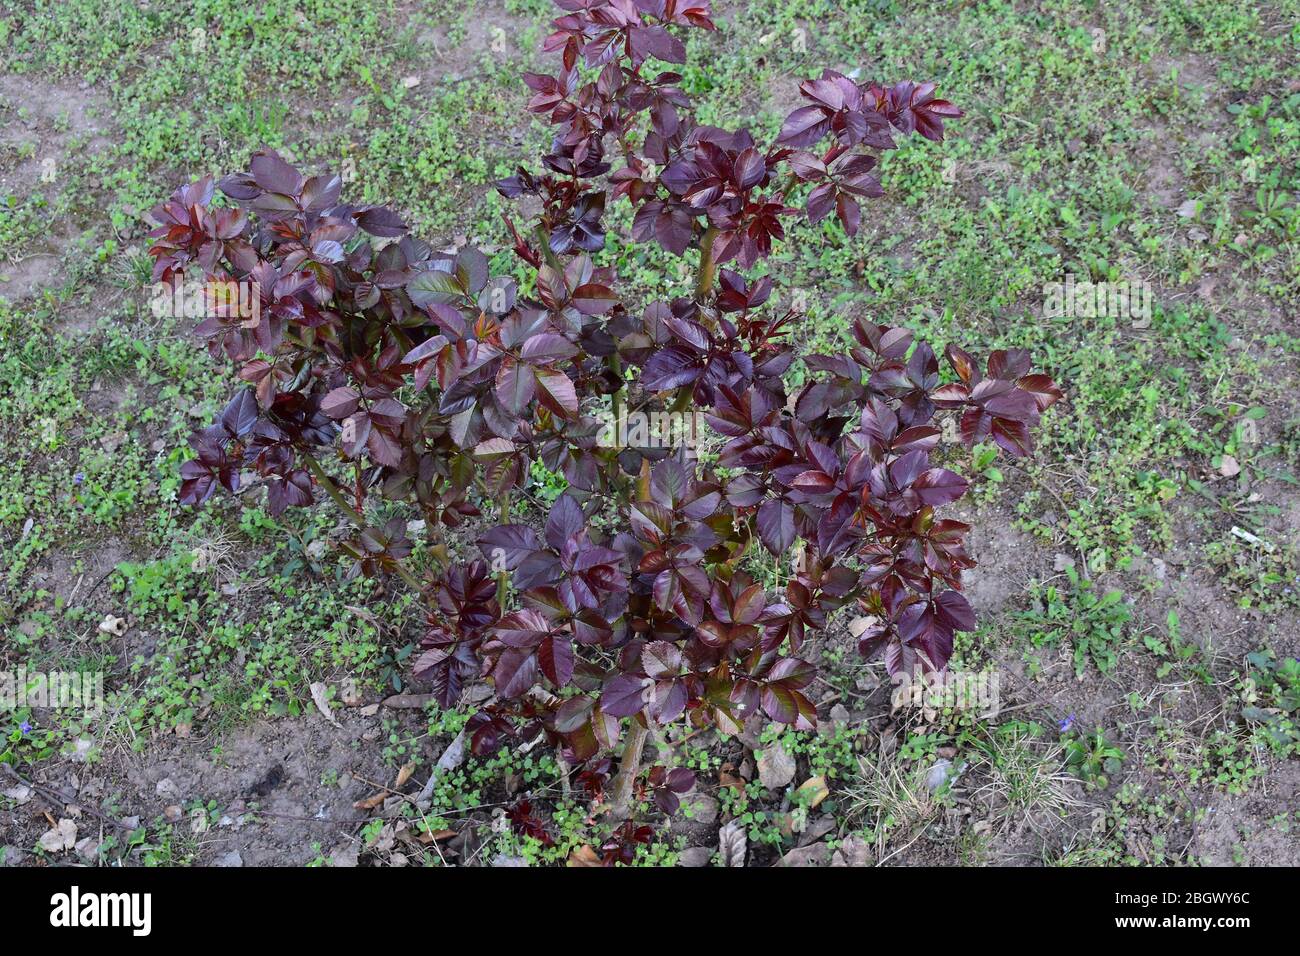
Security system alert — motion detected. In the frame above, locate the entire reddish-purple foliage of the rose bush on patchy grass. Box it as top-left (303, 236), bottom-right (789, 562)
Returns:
top-left (152, 0), bottom-right (1061, 806)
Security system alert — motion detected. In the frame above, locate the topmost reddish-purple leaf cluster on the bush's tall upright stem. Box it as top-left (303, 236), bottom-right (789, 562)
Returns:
top-left (501, 7), bottom-right (962, 268)
